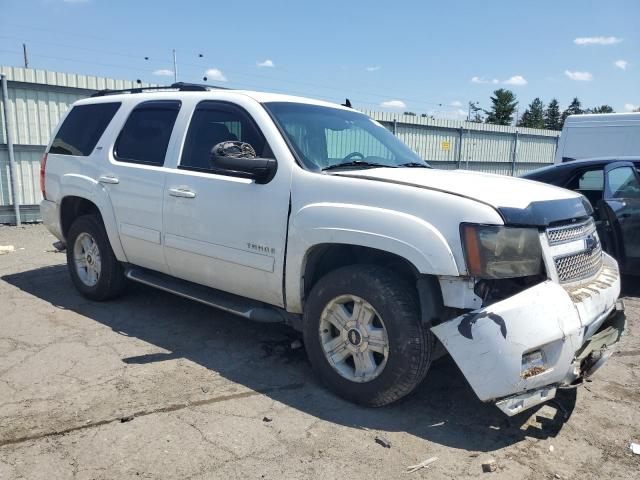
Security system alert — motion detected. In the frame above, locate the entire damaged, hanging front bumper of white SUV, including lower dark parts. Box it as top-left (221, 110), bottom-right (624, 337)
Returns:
top-left (431, 254), bottom-right (625, 416)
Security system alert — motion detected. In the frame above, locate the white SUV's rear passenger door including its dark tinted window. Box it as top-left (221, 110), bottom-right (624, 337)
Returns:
top-left (104, 100), bottom-right (181, 272)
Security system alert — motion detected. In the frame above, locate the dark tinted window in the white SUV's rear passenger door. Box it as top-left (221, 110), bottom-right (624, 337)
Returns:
top-left (115, 100), bottom-right (180, 165)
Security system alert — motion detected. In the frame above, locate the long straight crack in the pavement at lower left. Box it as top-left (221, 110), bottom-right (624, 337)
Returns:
top-left (0, 382), bottom-right (305, 447)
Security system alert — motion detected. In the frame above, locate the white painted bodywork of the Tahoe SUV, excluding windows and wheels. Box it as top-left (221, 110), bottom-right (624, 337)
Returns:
top-left (42, 90), bottom-right (620, 409)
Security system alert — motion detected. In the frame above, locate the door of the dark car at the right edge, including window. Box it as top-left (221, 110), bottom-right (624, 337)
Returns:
top-left (604, 162), bottom-right (640, 274)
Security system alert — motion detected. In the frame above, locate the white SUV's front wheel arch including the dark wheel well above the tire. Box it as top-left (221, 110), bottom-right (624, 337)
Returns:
top-left (284, 203), bottom-right (459, 313)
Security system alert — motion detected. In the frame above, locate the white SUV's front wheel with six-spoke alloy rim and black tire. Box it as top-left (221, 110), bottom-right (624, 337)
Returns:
top-left (303, 265), bottom-right (433, 406)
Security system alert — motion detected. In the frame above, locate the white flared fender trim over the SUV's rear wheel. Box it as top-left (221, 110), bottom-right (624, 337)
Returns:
top-left (60, 173), bottom-right (127, 262)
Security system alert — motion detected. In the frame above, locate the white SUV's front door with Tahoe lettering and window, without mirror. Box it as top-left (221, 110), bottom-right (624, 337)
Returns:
top-left (164, 101), bottom-right (290, 306)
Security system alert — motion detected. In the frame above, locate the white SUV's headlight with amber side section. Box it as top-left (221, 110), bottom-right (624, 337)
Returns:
top-left (460, 223), bottom-right (542, 279)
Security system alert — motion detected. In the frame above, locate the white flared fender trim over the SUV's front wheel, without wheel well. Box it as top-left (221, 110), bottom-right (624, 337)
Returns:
top-left (285, 203), bottom-right (459, 313)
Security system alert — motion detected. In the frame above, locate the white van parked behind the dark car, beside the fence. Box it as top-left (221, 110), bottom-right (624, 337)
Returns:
top-left (555, 112), bottom-right (640, 163)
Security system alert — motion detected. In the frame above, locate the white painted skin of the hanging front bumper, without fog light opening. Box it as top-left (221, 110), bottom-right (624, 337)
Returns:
top-left (431, 254), bottom-right (620, 401)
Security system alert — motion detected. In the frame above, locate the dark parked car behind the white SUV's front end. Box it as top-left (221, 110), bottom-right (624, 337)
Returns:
top-left (523, 158), bottom-right (640, 275)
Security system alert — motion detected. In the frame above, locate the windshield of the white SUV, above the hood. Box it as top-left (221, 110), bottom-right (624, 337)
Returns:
top-left (265, 102), bottom-right (428, 171)
